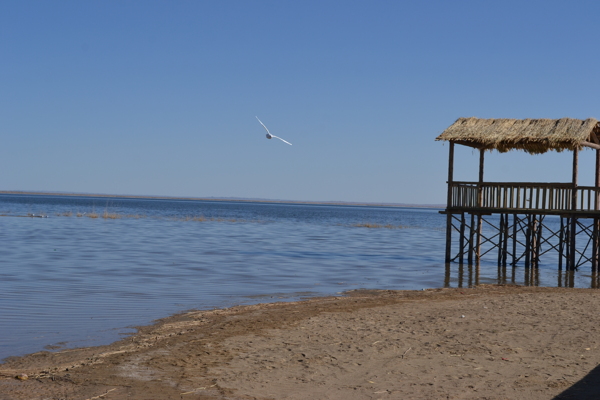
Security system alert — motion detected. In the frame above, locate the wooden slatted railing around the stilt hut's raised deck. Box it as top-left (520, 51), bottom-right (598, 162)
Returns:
top-left (449, 182), bottom-right (600, 212)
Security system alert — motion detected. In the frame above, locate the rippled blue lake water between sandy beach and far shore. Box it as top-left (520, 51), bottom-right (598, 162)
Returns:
top-left (0, 195), bottom-right (591, 359)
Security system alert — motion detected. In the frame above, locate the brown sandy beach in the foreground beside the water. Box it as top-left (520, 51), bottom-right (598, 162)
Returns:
top-left (0, 286), bottom-right (600, 400)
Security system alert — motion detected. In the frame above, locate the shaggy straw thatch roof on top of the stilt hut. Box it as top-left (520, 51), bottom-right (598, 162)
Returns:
top-left (435, 118), bottom-right (600, 154)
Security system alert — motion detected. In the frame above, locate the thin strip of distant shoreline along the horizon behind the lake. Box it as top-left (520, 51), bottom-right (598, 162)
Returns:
top-left (0, 190), bottom-right (446, 208)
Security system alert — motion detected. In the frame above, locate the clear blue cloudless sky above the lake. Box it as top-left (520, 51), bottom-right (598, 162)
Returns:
top-left (0, 0), bottom-right (600, 204)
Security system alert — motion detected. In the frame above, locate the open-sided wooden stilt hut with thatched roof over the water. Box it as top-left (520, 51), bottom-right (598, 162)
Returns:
top-left (436, 118), bottom-right (600, 270)
